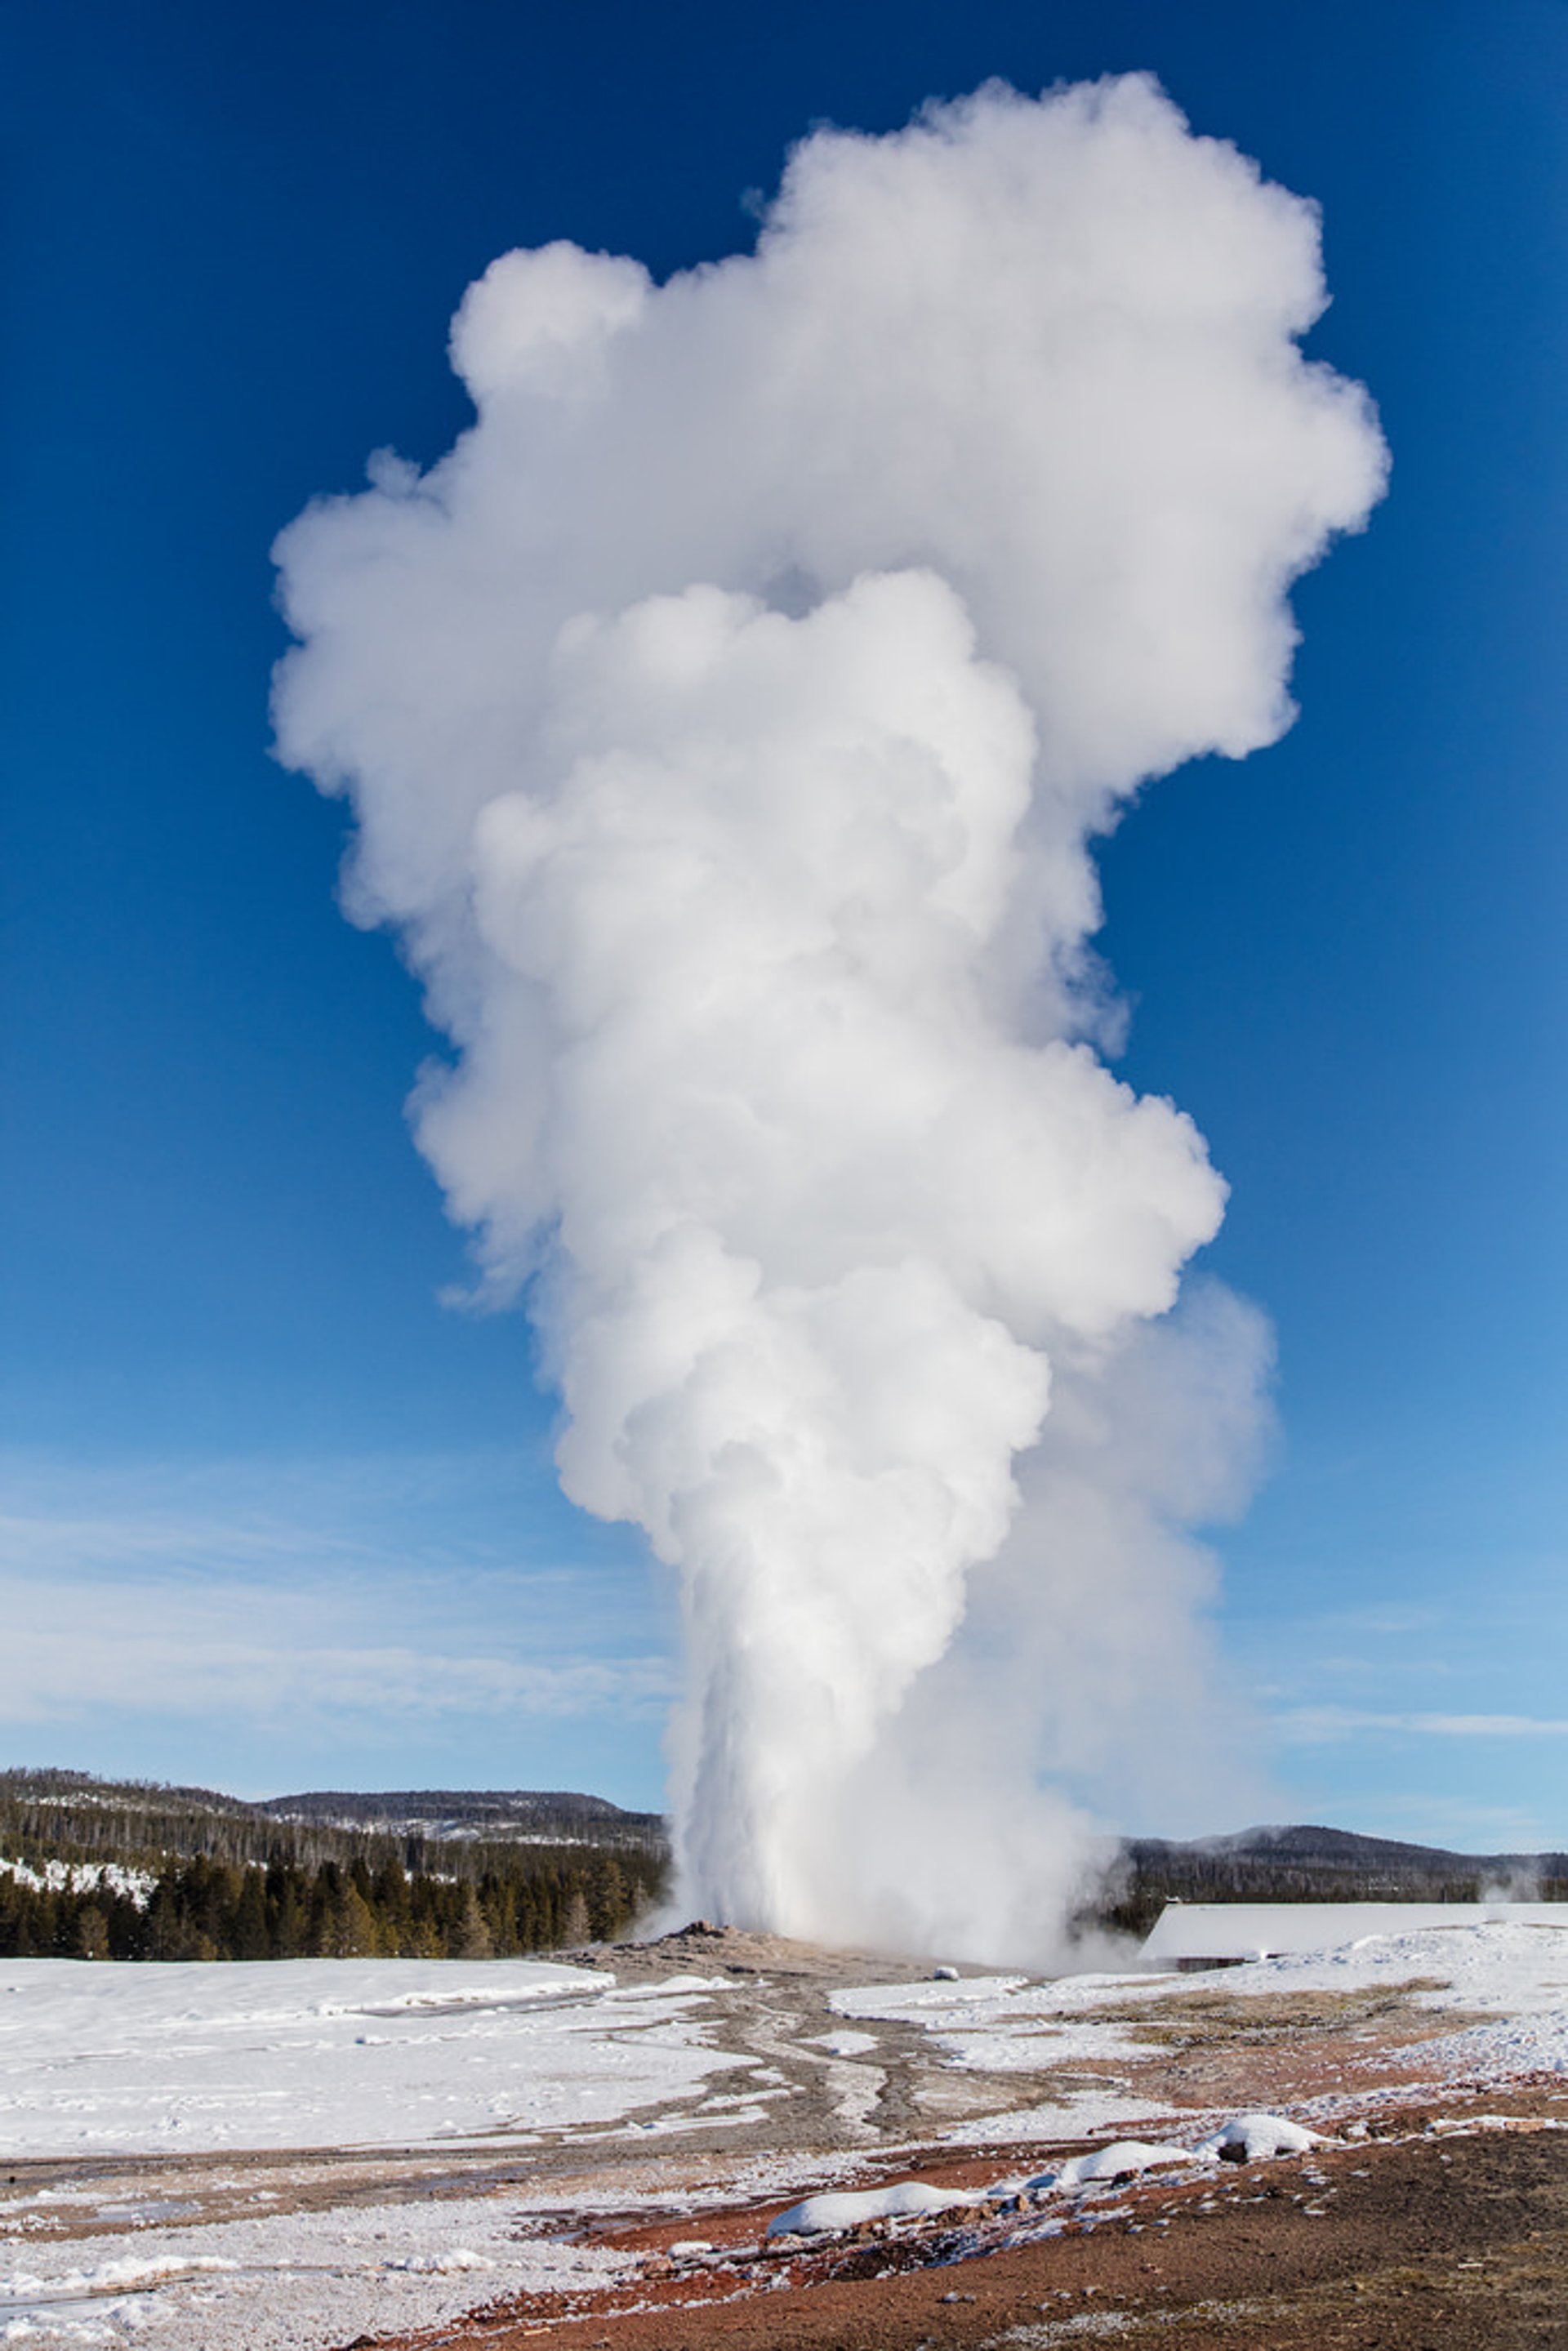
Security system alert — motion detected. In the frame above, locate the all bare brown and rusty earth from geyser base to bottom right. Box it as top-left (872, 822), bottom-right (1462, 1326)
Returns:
top-left (310, 1935), bottom-right (1568, 2351)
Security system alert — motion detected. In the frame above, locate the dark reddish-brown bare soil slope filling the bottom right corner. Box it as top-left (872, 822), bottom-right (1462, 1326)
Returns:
top-left (350, 2078), bottom-right (1568, 2351)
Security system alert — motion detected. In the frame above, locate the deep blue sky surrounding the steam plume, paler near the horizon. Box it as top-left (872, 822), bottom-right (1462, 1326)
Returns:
top-left (0, 0), bottom-right (1568, 1846)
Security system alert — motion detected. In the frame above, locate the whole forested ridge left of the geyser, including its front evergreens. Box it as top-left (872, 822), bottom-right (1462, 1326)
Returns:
top-left (0, 1770), bottom-right (666, 1958)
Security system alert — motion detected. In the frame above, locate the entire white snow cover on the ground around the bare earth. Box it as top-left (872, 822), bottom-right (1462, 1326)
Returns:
top-left (0, 1912), bottom-right (1568, 2351)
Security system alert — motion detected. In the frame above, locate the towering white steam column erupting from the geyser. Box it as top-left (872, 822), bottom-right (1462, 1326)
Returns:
top-left (278, 78), bottom-right (1383, 1956)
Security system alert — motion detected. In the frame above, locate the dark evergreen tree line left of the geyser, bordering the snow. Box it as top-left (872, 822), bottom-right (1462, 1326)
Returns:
top-left (0, 1848), bottom-right (663, 1961)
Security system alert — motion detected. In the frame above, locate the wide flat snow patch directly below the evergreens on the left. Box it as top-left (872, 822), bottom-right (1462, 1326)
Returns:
top-left (0, 1958), bottom-right (736, 2156)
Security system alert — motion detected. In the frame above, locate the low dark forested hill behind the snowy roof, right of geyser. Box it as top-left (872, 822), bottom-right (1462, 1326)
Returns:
top-left (1095, 1827), bottom-right (1568, 1933)
